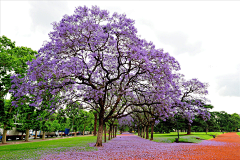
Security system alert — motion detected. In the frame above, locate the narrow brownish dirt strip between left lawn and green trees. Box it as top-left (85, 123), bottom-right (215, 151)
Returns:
top-left (0, 135), bottom-right (92, 146)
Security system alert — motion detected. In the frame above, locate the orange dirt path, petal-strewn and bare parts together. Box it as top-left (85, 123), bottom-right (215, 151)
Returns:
top-left (42, 133), bottom-right (240, 160)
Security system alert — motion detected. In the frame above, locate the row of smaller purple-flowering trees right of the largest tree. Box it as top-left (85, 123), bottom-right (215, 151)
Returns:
top-left (119, 75), bottom-right (212, 140)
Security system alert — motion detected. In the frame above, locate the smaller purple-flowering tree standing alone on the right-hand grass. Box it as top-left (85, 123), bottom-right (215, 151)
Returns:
top-left (174, 78), bottom-right (210, 134)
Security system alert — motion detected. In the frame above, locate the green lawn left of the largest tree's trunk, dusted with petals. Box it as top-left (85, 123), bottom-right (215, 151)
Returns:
top-left (0, 136), bottom-right (111, 160)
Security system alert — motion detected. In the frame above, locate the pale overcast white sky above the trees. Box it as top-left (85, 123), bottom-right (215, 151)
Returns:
top-left (0, 1), bottom-right (240, 114)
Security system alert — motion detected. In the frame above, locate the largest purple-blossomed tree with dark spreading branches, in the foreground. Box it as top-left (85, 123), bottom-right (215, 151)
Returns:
top-left (12, 6), bottom-right (180, 146)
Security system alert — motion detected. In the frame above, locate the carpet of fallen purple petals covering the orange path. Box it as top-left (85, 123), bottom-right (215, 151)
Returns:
top-left (42, 133), bottom-right (239, 160)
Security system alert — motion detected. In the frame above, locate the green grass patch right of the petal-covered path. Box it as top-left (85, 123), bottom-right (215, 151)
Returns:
top-left (136, 132), bottom-right (222, 143)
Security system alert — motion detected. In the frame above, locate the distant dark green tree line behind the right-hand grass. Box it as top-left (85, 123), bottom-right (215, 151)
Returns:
top-left (124, 111), bottom-right (240, 134)
